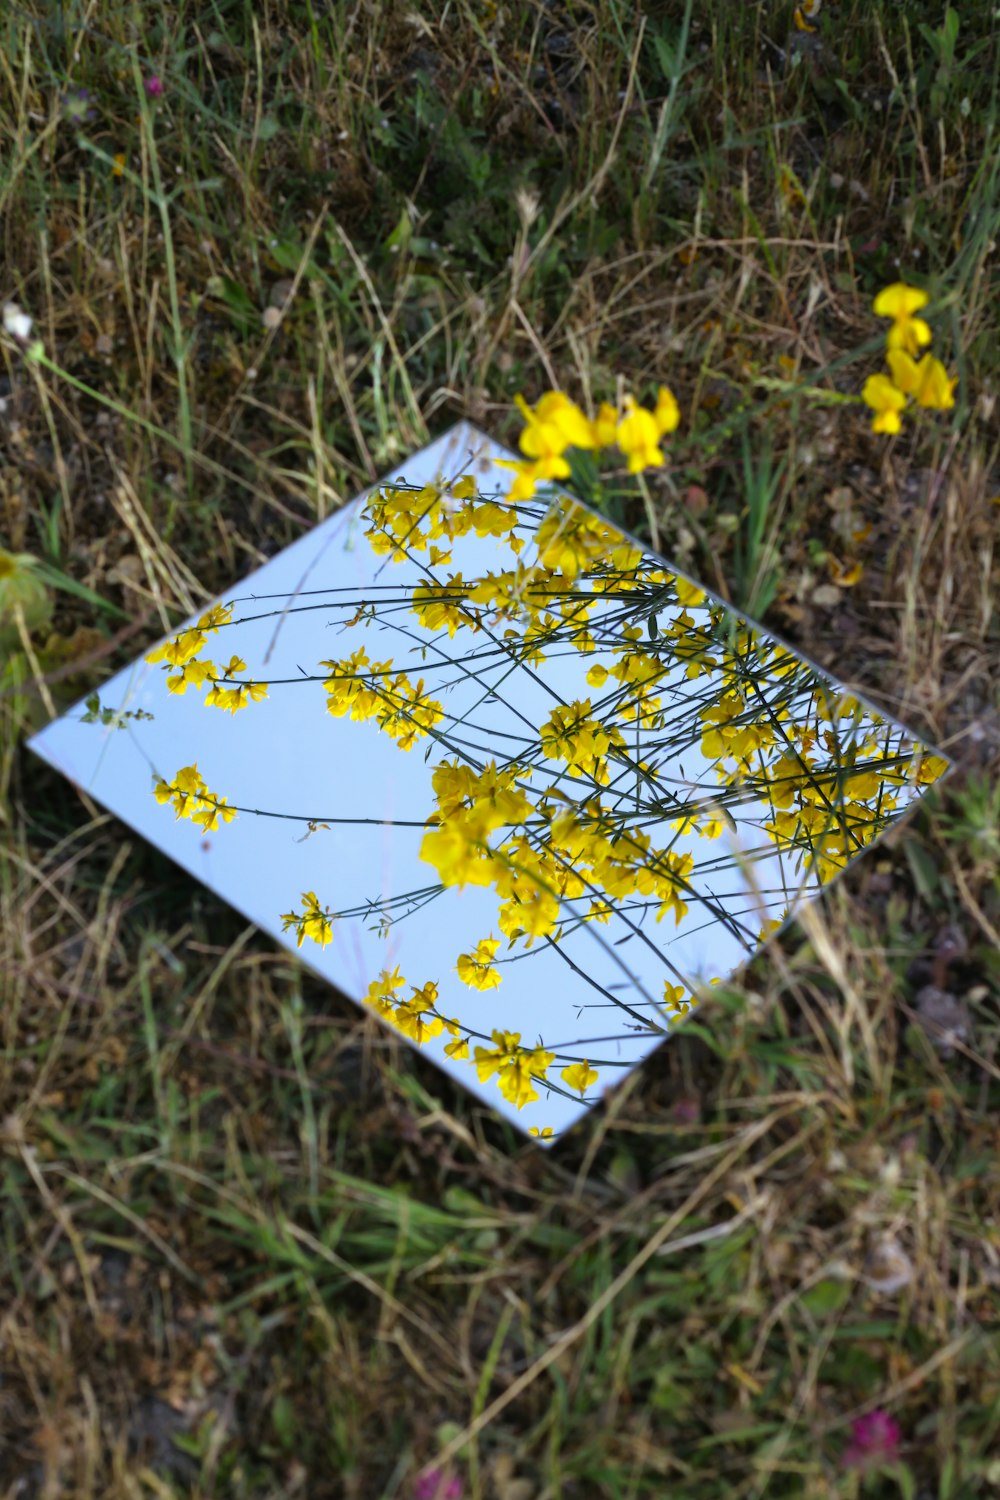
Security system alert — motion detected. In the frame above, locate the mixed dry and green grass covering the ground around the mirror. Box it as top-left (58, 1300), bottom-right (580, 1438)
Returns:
top-left (0, 0), bottom-right (1000, 1500)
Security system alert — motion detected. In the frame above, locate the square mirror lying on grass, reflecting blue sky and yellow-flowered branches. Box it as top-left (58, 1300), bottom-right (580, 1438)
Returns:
top-left (30, 423), bottom-right (948, 1142)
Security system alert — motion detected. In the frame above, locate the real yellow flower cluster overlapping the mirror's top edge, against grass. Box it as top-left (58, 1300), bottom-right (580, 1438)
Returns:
top-left (498, 386), bottom-right (681, 501)
